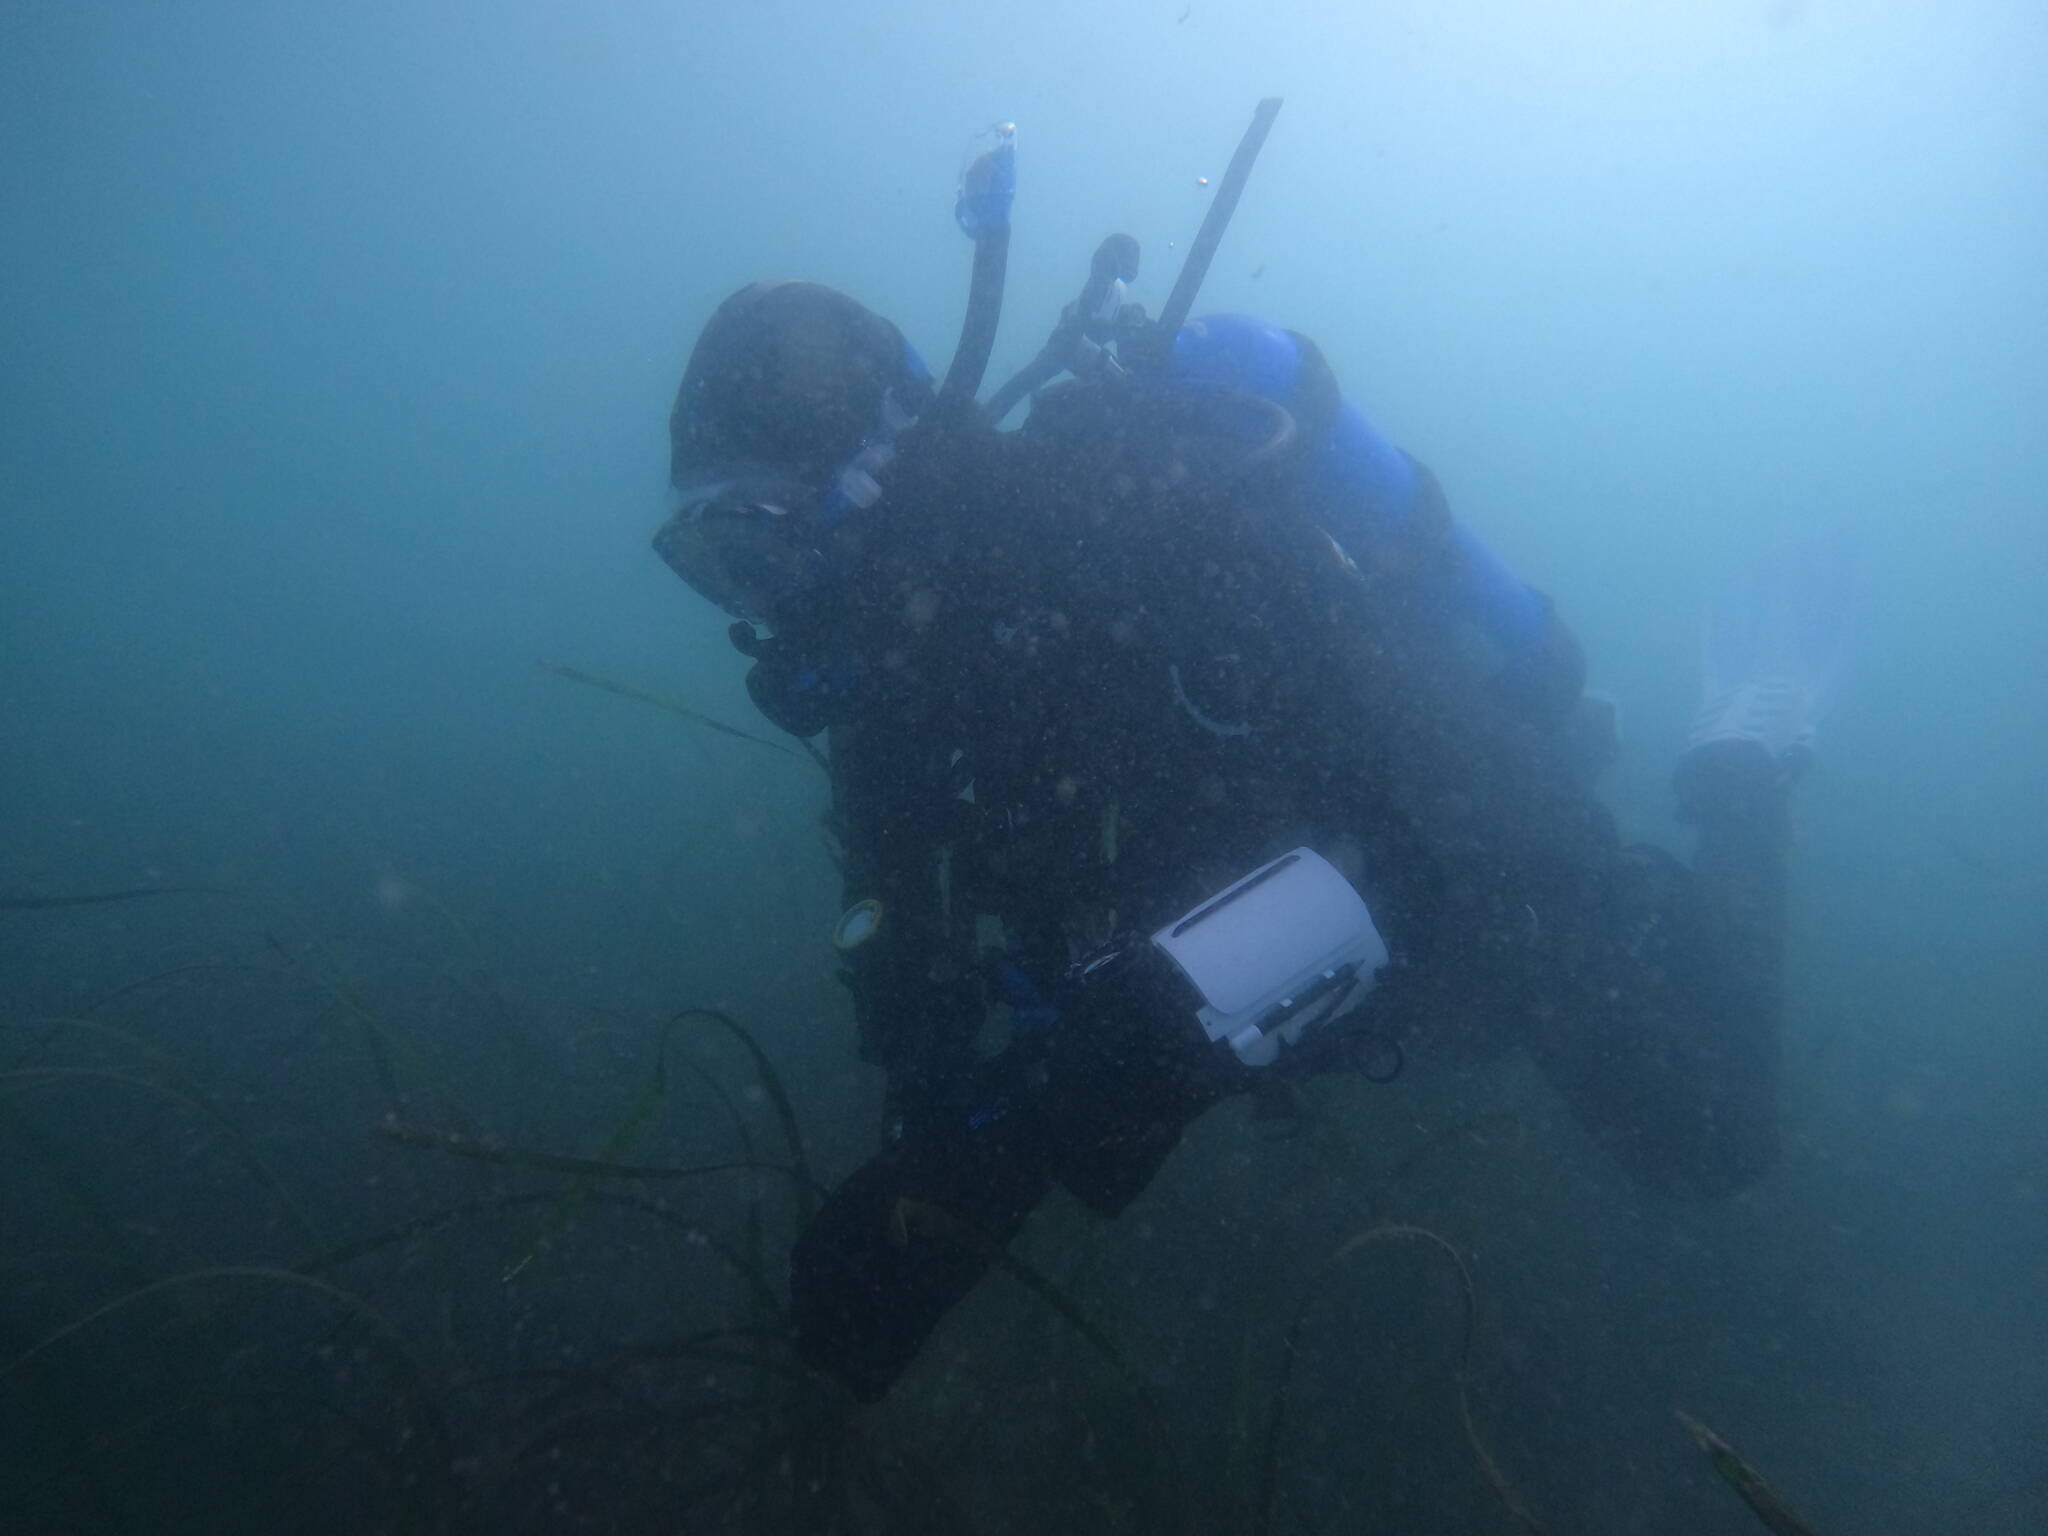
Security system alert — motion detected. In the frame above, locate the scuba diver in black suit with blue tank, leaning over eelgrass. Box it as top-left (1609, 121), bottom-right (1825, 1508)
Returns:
top-left (655, 102), bottom-right (1817, 1401)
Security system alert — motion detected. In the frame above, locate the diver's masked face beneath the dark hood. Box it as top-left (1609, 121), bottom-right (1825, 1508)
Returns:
top-left (653, 467), bottom-right (823, 625)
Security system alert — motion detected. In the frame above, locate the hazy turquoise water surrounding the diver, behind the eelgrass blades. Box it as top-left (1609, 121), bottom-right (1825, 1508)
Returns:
top-left (0, 0), bottom-right (2048, 1532)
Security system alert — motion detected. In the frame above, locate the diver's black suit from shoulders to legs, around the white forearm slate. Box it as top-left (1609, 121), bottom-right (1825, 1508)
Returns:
top-left (758, 387), bottom-right (1786, 1397)
